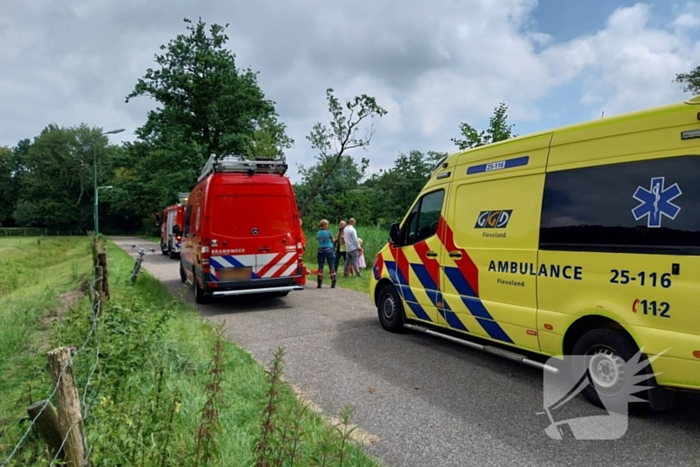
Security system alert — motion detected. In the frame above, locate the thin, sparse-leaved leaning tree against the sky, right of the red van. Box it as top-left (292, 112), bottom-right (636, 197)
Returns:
top-left (299, 88), bottom-right (387, 217)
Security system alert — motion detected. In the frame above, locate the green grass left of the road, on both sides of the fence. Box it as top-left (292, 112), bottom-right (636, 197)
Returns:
top-left (0, 237), bottom-right (378, 466)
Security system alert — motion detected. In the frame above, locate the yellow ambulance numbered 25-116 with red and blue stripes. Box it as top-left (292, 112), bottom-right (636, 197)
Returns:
top-left (370, 96), bottom-right (700, 408)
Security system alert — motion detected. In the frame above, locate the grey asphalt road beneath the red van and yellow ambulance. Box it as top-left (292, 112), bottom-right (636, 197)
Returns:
top-left (113, 237), bottom-right (700, 467)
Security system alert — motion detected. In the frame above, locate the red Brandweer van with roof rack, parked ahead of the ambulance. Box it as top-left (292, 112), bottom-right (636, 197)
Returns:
top-left (180, 156), bottom-right (305, 303)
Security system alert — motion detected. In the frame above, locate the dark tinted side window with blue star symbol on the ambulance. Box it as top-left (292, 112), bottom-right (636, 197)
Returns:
top-left (540, 156), bottom-right (700, 254)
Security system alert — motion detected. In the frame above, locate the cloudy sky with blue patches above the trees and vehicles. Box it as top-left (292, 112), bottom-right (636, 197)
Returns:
top-left (0, 0), bottom-right (700, 179)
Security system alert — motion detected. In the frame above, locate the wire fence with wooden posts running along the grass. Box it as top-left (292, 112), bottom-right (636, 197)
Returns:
top-left (0, 239), bottom-right (109, 467)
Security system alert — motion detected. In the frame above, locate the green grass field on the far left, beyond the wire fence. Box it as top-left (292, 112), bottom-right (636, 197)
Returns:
top-left (0, 237), bottom-right (91, 465)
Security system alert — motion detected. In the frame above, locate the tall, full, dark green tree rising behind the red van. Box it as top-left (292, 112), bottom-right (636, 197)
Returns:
top-left (126, 18), bottom-right (289, 165)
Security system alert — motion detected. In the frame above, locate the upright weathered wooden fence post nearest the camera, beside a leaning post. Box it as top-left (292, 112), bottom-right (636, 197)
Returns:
top-left (48, 347), bottom-right (87, 467)
